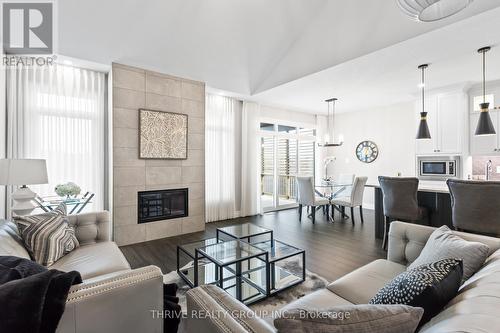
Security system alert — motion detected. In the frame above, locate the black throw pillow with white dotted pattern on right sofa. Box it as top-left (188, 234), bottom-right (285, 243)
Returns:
top-left (370, 259), bottom-right (463, 324)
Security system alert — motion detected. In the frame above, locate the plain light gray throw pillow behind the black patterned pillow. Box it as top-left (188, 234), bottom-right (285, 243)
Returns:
top-left (408, 226), bottom-right (490, 283)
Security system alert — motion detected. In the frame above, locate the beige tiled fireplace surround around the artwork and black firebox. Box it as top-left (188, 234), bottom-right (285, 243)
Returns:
top-left (113, 64), bottom-right (205, 245)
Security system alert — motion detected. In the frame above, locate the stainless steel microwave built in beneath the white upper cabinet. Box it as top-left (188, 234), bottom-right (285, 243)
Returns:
top-left (417, 156), bottom-right (460, 180)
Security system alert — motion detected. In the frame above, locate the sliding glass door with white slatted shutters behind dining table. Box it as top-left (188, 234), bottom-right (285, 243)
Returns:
top-left (261, 123), bottom-right (315, 212)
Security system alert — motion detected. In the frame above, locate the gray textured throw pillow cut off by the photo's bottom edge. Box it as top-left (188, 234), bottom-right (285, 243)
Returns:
top-left (274, 304), bottom-right (424, 333)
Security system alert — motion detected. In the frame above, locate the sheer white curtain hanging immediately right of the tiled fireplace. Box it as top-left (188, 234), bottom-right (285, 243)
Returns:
top-left (205, 94), bottom-right (238, 222)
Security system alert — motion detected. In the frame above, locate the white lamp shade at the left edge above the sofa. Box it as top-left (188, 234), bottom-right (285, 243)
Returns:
top-left (0, 159), bottom-right (49, 185)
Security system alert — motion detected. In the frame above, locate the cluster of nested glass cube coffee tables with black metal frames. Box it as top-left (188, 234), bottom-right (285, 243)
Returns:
top-left (177, 223), bottom-right (306, 304)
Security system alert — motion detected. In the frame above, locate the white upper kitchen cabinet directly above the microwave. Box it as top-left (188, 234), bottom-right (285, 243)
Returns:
top-left (416, 92), bottom-right (467, 155)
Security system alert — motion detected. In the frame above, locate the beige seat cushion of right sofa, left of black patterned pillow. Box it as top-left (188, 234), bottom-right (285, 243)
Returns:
top-left (327, 259), bottom-right (406, 304)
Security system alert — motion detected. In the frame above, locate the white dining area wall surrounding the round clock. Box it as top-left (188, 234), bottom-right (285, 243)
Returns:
top-left (328, 102), bottom-right (418, 208)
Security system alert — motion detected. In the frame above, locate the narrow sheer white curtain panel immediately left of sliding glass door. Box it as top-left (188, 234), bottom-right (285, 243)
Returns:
top-left (240, 102), bottom-right (261, 216)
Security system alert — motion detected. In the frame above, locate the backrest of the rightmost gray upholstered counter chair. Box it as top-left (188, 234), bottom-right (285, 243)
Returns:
top-left (446, 179), bottom-right (500, 237)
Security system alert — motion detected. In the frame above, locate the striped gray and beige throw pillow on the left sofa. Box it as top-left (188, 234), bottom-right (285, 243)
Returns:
top-left (14, 203), bottom-right (79, 266)
